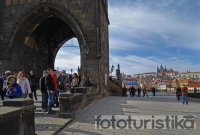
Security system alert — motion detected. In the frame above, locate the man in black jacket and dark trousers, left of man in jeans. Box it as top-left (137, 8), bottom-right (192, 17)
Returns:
top-left (39, 70), bottom-right (48, 112)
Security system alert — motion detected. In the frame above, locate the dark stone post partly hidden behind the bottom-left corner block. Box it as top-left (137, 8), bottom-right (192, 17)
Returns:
top-left (3, 98), bottom-right (35, 135)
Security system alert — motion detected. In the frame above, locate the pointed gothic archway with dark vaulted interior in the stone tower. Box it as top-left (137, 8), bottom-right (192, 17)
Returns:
top-left (9, 3), bottom-right (85, 72)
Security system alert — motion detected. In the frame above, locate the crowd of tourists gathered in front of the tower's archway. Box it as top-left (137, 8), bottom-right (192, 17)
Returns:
top-left (0, 68), bottom-right (92, 114)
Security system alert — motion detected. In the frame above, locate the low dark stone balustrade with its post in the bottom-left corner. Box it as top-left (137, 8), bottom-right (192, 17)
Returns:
top-left (0, 98), bottom-right (35, 135)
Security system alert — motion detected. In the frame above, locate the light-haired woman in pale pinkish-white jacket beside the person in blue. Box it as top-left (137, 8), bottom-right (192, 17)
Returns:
top-left (17, 71), bottom-right (33, 99)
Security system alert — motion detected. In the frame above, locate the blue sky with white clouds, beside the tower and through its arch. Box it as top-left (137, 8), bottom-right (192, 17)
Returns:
top-left (56, 0), bottom-right (200, 74)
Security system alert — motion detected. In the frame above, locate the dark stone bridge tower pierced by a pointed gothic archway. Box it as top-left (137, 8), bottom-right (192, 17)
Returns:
top-left (0, 0), bottom-right (109, 94)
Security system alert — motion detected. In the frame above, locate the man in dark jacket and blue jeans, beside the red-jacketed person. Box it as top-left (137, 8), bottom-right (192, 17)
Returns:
top-left (45, 71), bottom-right (55, 114)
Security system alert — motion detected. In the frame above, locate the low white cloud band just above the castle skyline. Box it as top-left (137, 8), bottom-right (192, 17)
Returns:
top-left (110, 55), bottom-right (200, 74)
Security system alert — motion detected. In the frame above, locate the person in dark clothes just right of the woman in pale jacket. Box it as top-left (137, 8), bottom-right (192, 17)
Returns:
top-left (28, 70), bottom-right (38, 100)
